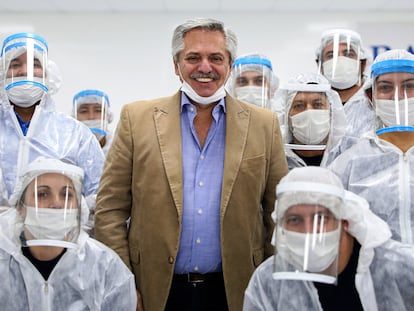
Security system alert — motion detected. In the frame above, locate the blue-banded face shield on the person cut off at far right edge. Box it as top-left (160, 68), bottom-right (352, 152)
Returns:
top-left (371, 59), bottom-right (414, 135)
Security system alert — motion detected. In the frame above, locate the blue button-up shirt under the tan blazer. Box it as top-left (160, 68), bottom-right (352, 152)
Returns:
top-left (175, 93), bottom-right (226, 274)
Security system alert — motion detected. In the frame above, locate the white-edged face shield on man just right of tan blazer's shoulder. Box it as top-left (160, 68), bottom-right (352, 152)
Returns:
top-left (285, 84), bottom-right (331, 150)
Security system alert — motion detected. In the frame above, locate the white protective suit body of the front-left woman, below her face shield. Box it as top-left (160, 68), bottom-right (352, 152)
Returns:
top-left (0, 208), bottom-right (137, 311)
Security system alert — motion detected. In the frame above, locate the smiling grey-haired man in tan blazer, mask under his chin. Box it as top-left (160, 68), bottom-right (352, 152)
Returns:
top-left (95, 18), bottom-right (287, 311)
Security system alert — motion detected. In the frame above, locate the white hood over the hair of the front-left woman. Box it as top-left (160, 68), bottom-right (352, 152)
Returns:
top-left (10, 157), bottom-right (84, 206)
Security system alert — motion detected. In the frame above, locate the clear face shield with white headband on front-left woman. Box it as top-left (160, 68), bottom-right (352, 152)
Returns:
top-left (14, 159), bottom-right (83, 248)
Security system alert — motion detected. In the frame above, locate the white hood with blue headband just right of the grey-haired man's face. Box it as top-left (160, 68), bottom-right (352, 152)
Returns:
top-left (227, 53), bottom-right (279, 97)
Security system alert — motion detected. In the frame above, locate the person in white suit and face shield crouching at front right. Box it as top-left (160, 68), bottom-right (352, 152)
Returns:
top-left (243, 166), bottom-right (414, 311)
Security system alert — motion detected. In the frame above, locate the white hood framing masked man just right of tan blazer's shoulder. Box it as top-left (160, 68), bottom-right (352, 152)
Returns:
top-left (277, 73), bottom-right (347, 149)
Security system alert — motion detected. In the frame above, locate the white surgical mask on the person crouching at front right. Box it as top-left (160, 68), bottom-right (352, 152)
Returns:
top-left (282, 226), bottom-right (341, 272)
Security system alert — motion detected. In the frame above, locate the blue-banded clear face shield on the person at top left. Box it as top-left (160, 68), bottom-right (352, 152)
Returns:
top-left (2, 37), bottom-right (47, 92)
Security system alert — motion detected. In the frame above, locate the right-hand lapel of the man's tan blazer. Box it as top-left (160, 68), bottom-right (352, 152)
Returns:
top-left (220, 95), bottom-right (250, 217)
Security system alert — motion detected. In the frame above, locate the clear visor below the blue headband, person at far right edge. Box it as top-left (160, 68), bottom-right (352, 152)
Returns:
top-left (372, 72), bottom-right (414, 134)
